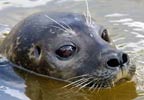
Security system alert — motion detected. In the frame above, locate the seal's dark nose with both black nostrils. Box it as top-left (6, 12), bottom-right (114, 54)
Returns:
top-left (107, 53), bottom-right (129, 67)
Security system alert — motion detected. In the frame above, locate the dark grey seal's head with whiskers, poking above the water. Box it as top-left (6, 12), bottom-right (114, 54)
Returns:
top-left (0, 12), bottom-right (135, 88)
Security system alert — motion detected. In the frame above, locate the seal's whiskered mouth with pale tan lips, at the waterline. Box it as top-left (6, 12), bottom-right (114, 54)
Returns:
top-left (65, 68), bottom-right (133, 89)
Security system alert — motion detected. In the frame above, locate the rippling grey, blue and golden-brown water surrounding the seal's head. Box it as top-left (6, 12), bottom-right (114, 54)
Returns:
top-left (0, 0), bottom-right (144, 100)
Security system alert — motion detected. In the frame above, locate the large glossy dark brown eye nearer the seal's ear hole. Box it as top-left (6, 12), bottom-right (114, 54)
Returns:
top-left (55, 45), bottom-right (76, 59)
